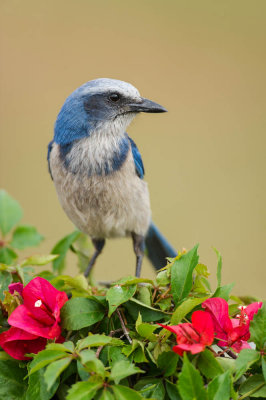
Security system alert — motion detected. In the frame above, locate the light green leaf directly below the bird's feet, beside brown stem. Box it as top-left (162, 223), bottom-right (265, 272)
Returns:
top-left (106, 285), bottom-right (137, 317)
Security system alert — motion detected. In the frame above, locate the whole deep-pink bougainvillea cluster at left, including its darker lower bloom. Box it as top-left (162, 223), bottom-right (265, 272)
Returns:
top-left (0, 277), bottom-right (68, 360)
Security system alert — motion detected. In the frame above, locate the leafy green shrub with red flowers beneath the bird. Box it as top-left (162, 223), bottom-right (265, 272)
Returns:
top-left (0, 191), bottom-right (266, 400)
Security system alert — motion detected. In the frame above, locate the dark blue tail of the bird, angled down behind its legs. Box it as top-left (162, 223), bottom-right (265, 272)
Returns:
top-left (145, 222), bottom-right (177, 269)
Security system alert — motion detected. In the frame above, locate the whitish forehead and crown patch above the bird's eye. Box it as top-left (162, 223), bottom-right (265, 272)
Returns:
top-left (77, 78), bottom-right (140, 98)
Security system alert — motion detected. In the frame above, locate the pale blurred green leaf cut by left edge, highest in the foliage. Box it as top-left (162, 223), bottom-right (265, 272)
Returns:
top-left (0, 190), bottom-right (22, 236)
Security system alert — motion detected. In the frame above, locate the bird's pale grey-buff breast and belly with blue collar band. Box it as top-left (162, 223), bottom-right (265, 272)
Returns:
top-left (49, 134), bottom-right (151, 238)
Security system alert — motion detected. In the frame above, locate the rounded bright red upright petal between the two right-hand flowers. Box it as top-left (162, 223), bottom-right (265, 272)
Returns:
top-left (192, 311), bottom-right (214, 345)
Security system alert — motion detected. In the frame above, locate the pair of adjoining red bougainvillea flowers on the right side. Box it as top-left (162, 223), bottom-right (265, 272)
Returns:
top-left (158, 297), bottom-right (262, 356)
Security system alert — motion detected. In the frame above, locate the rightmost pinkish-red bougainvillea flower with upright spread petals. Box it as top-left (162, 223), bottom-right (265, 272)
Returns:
top-left (202, 297), bottom-right (262, 353)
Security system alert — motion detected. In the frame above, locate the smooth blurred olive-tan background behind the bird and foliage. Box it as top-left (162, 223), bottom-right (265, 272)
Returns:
top-left (0, 0), bottom-right (266, 297)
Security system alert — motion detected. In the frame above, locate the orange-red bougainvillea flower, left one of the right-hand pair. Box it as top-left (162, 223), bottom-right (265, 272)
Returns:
top-left (158, 311), bottom-right (214, 356)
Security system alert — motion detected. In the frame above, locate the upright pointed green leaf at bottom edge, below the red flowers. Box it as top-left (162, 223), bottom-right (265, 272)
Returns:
top-left (177, 353), bottom-right (207, 400)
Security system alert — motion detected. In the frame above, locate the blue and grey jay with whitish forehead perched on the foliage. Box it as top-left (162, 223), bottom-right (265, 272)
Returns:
top-left (47, 78), bottom-right (177, 277)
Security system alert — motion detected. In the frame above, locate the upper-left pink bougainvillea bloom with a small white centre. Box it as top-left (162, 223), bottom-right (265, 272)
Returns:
top-left (8, 277), bottom-right (68, 339)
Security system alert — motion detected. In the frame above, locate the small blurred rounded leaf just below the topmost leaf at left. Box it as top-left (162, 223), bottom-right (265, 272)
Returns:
top-left (10, 225), bottom-right (43, 250)
